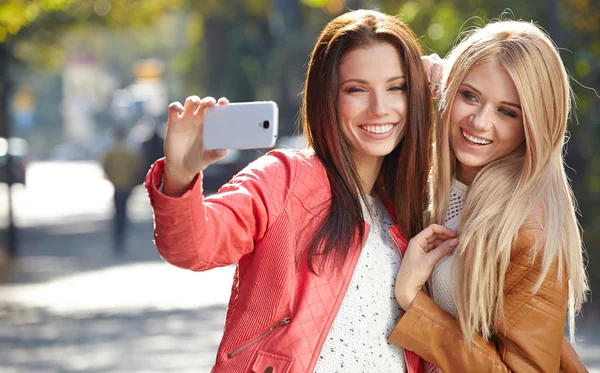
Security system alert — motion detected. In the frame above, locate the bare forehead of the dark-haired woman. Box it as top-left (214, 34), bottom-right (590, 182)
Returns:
top-left (340, 42), bottom-right (404, 80)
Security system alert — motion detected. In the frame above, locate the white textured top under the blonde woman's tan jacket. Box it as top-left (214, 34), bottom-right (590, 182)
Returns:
top-left (425, 179), bottom-right (469, 373)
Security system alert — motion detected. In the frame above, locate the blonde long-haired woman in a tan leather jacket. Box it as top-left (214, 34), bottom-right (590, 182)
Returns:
top-left (389, 21), bottom-right (588, 373)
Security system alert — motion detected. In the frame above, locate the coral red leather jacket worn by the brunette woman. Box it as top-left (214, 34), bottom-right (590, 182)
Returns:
top-left (146, 150), bottom-right (422, 373)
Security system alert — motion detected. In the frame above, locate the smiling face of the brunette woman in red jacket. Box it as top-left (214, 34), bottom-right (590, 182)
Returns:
top-left (337, 42), bottom-right (408, 164)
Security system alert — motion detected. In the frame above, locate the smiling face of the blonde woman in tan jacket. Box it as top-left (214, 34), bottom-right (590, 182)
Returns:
top-left (450, 60), bottom-right (525, 184)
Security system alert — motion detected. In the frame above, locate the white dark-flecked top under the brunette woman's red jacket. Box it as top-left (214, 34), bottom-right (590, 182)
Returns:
top-left (314, 197), bottom-right (406, 373)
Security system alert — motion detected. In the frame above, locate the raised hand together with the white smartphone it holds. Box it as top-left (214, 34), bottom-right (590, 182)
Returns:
top-left (164, 96), bottom-right (278, 196)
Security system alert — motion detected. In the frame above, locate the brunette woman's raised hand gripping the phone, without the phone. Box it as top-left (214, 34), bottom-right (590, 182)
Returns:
top-left (163, 96), bottom-right (229, 196)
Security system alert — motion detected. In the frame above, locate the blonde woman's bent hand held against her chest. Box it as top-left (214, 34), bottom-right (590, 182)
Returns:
top-left (395, 224), bottom-right (458, 310)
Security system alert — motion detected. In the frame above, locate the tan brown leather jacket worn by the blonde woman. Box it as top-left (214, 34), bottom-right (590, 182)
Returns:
top-left (389, 224), bottom-right (587, 373)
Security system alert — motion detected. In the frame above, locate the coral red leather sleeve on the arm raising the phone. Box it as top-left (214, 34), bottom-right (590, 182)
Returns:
top-left (145, 153), bottom-right (292, 271)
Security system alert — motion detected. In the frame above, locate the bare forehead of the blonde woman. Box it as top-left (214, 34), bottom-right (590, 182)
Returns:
top-left (463, 60), bottom-right (519, 103)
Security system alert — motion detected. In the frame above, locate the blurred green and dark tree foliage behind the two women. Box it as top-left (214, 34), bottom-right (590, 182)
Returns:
top-left (0, 0), bottom-right (600, 306)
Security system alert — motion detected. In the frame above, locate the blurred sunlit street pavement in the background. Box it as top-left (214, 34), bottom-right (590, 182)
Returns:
top-left (0, 163), bottom-right (600, 373)
